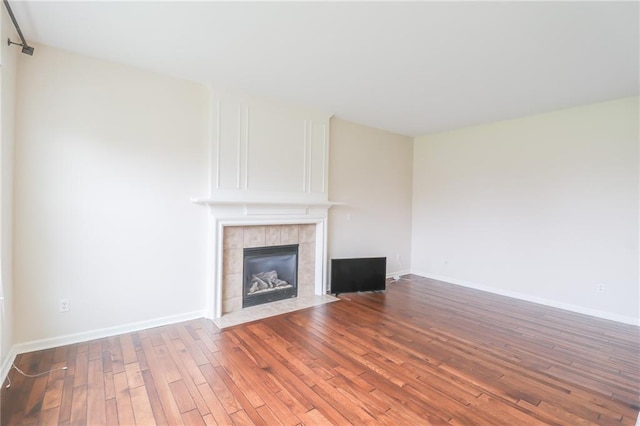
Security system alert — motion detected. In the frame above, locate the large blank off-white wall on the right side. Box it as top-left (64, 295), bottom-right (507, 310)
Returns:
top-left (412, 97), bottom-right (640, 322)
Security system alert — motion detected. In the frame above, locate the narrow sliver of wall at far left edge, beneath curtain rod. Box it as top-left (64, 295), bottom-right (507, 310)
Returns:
top-left (0, 7), bottom-right (19, 370)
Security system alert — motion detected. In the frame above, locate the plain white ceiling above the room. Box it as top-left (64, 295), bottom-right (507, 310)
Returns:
top-left (6, 0), bottom-right (640, 136)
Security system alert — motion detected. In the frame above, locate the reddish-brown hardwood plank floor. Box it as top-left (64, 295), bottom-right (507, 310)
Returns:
top-left (1, 276), bottom-right (640, 425)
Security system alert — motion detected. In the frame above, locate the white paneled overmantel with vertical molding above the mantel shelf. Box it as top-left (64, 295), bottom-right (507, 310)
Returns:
top-left (210, 91), bottom-right (330, 202)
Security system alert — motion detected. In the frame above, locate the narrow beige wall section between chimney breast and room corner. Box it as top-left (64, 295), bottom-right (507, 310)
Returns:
top-left (329, 118), bottom-right (412, 274)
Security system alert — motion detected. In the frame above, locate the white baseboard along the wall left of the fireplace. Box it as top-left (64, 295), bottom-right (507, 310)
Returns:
top-left (0, 311), bottom-right (205, 381)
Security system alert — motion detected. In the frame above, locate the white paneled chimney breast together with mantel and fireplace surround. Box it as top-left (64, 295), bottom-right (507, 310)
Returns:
top-left (192, 91), bottom-right (340, 319)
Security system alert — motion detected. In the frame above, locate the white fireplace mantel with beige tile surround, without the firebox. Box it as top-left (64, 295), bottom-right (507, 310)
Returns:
top-left (193, 198), bottom-right (339, 319)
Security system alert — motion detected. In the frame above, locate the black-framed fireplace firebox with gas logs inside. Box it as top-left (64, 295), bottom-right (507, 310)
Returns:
top-left (242, 244), bottom-right (298, 308)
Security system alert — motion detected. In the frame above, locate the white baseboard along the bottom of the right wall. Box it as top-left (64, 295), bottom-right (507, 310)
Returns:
top-left (411, 271), bottom-right (640, 326)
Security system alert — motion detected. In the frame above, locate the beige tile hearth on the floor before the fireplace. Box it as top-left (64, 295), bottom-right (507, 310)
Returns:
top-left (213, 294), bottom-right (340, 328)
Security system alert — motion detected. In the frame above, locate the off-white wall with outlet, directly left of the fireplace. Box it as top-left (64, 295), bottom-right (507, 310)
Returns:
top-left (14, 46), bottom-right (210, 343)
